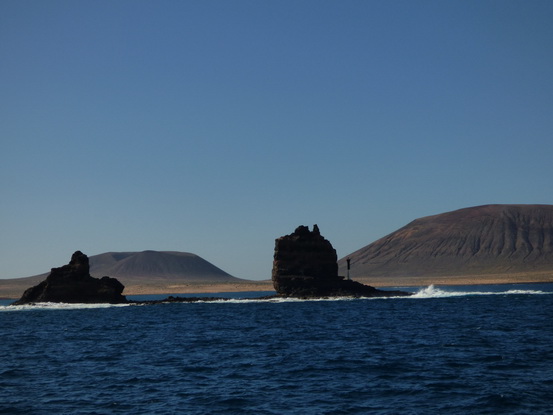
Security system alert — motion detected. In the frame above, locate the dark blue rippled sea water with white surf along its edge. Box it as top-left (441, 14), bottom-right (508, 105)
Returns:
top-left (0, 284), bottom-right (553, 414)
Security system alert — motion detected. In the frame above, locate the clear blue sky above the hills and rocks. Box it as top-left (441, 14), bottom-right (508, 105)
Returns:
top-left (0, 0), bottom-right (553, 279)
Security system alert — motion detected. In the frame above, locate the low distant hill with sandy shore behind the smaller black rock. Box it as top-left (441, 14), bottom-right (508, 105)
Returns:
top-left (0, 251), bottom-right (272, 298)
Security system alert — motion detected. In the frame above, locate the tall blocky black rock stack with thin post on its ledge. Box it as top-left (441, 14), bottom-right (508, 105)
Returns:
top-left (272, 225), bottom-right (409, 298)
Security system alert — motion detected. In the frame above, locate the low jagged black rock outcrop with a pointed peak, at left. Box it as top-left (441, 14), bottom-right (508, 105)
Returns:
top-left (13, 251), bottom-right (127, 305)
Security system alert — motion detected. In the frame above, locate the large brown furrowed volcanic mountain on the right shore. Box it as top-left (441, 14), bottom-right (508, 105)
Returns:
top-left (339, 205), bottom-right (553, 281)
